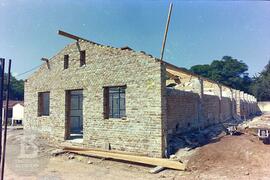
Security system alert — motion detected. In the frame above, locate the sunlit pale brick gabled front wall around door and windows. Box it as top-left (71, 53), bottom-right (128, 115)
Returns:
top-left (24, 41), bottom-right (166, 157)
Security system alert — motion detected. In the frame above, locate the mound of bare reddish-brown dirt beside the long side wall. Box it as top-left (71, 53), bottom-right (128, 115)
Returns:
top-left (188, 135), bottom-right (270, 177)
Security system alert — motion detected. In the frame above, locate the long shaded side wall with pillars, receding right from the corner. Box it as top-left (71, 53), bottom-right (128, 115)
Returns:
top-left (167, 67), bottom-right (258, 136)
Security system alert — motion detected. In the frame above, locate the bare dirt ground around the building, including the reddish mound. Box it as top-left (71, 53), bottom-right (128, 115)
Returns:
top-left (5, 113), bottom-right (270, 180)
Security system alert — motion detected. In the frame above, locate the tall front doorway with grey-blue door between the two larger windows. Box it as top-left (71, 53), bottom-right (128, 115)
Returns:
top-left (66, 90), bottom-right (83, 139)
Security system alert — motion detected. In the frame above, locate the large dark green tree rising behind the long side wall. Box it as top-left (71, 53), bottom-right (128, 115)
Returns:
top-left (190, 56), bottom-right (252, 92)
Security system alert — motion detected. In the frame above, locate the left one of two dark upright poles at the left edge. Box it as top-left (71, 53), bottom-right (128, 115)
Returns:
top-left (0, 59), bottom-right (5, 166)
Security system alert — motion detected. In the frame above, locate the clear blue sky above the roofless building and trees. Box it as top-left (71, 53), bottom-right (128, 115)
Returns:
top-left (0, 0), bottom-right (270, 78)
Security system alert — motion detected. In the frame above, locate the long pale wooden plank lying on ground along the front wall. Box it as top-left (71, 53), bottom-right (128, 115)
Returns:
top-left (64, 148), bottom-right (186, 170)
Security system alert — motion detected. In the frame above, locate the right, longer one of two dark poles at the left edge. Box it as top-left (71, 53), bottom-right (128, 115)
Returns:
top-left (1, 60), bottom-right (11, 180)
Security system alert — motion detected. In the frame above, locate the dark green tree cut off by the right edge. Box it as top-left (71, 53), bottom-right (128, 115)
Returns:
top-left (251, 61), bottom-right (270, 101)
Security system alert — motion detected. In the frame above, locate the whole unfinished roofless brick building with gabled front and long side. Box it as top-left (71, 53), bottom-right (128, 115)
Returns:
top-left (24, 32), bottom-right (257, 157)
